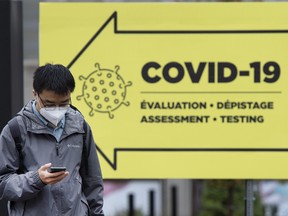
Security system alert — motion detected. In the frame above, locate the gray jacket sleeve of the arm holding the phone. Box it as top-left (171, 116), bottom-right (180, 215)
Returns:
top-left (0, 125), bottom-right (45, 201)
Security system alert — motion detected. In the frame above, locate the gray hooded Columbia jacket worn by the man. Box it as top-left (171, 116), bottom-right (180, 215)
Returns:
top-left (0, 101), bottom-right (104, 216)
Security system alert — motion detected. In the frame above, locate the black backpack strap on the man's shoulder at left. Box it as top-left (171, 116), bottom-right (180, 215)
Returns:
top-left (8, 117), bottom-right (24, 173)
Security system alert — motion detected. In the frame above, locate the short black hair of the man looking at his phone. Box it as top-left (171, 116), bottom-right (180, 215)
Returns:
top-left (33, 64), bottom-right (75, 95)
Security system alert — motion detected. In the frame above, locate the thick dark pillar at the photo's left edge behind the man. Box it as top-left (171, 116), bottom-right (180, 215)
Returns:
top-left (0, 0), bottom-right (23, 216)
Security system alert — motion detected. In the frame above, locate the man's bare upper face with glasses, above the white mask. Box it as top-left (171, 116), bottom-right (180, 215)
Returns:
top-left (36, 90), bottom-right (71, 111)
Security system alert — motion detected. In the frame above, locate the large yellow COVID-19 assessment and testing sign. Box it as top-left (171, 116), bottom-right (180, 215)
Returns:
top-left (40, 3), bottom-right (288, 179)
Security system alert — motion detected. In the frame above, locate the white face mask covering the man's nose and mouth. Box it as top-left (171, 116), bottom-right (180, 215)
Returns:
top-left (40, 107), bottom-right (68, 126)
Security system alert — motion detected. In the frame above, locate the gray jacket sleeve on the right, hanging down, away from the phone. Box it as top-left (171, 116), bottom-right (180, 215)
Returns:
top-left (80, 123), bottom-right (104, 216)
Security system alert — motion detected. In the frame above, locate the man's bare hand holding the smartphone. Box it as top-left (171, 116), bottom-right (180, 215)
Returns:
top-left (38, 163), bottom-right (69, 184)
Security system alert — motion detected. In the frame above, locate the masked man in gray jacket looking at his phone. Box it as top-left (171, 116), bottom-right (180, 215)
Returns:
top-left (0, 64), bottom-right (104, 216)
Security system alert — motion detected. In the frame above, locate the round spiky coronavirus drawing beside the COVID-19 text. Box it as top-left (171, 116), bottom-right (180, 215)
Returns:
top-left (77, 63), bottom-right (132, 119)
